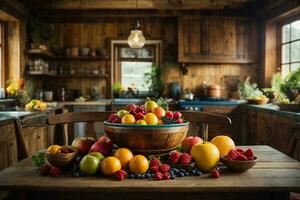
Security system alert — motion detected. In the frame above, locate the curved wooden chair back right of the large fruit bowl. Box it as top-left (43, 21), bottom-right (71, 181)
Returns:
top-left (180, 111), bottom-right (231, 141)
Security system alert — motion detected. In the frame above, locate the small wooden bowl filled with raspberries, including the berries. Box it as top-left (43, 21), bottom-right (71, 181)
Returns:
top-left (221, 149), bottom-right (257, 172)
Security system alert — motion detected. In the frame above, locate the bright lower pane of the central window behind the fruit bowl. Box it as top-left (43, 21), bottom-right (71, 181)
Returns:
top-left (121, 62), bottom-right (153, 91)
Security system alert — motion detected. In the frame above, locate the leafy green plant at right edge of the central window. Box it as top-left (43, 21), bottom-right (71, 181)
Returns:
top-left (144, 65), bottom-right (165, 96)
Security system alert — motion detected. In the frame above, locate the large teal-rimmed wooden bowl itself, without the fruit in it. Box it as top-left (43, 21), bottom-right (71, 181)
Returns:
top-left (104, 121), bottom-right (189, 155)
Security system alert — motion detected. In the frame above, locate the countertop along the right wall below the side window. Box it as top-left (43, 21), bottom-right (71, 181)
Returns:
top-left (243, 103), bottom-right (300, 121)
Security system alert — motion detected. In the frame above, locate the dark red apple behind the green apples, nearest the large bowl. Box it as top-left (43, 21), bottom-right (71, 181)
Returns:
top-left (90, 136), bottom-right (113, 156)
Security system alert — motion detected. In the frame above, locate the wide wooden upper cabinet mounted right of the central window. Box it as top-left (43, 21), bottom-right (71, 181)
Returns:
top-left (178, 16), bottom-right (257, 63)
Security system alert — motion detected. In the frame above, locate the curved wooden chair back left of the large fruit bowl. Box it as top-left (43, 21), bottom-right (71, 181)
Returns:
top-left (48, 111), bottom-right (114, 145)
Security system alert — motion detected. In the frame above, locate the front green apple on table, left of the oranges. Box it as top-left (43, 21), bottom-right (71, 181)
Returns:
top-left (79, 155), bottom-right (100, 175)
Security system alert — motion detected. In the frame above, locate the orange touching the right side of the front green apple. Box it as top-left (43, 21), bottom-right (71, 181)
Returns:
top-left (101, 156), bottom-right (121, 176)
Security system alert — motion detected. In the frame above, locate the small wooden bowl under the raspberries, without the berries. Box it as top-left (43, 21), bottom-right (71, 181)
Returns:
top-left (221, 156), bottom-right (257, 172)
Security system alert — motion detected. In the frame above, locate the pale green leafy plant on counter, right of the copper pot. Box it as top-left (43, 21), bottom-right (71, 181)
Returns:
top-left (238, 77), bottom-right (263, 99)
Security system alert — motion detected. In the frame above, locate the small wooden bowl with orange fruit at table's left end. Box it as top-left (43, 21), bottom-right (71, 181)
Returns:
top-left (46, 145), bottom-right (77, 167)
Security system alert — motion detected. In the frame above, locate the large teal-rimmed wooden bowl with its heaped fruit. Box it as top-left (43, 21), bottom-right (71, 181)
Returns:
top-left (104, 99), bottom-right (189, 155)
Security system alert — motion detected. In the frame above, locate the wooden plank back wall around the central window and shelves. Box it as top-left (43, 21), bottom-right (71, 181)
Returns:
top-left (32, 17), bottom-right (258, 97)
